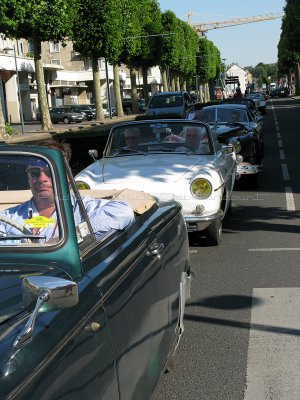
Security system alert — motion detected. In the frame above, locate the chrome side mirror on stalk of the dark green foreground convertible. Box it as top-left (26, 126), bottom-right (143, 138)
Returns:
top-left (13, 276), bottom-right (78, 348)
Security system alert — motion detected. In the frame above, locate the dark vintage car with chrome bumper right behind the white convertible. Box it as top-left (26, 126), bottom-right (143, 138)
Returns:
top-left (187, 104), bottom-right (264, 179)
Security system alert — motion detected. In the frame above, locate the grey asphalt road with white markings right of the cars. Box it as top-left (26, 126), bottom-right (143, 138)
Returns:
top-left (154, 98), bottom-right (300, 400)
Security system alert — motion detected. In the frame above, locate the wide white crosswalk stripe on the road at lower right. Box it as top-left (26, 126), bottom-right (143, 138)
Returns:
top-left (244, 288), bottom-right (300, 400)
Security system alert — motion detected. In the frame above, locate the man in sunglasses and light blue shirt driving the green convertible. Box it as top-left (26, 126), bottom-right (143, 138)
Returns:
top-left (0, 141), bottom-right (134, 242)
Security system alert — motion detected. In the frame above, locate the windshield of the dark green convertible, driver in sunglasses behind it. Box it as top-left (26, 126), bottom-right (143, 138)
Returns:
top-left (0, 154), bottom-right (62, 247)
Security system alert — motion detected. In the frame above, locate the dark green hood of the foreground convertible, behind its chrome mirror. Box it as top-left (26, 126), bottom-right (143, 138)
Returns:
top-left (0, 263), bottom-right (70, 328)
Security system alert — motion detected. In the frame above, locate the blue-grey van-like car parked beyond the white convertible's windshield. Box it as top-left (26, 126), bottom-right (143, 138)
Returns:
top-left (145, 91), bottom-right (194, 118)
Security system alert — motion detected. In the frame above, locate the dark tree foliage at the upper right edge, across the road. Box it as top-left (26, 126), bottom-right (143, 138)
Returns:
top-left (278, 0), bottom-right (300, 95)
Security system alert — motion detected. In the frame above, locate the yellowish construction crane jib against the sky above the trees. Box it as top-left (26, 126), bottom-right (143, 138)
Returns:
top-left (188, 12), bottom-right (283, 35)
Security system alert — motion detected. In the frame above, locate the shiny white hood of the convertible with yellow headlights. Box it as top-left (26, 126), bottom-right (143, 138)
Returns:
top-left (75, 154), bottom-right (213, 190)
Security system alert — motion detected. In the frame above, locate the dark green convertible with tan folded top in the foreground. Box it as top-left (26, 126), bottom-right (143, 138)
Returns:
top-left (0, 143), bottom-right (191, 400)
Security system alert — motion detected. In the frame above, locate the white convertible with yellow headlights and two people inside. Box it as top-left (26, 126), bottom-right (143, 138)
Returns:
top-left (75, 120), bottom-right (236, 245)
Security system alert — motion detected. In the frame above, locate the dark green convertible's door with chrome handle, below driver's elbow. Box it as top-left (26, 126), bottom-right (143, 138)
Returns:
top-left (79, 205), bottom-right (186, 400)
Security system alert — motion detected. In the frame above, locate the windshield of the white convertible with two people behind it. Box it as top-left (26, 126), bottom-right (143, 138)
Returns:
top-left (105, 121), bottom-right (213, 157)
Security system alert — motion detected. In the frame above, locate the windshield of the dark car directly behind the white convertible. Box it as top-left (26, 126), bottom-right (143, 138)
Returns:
top-left (188, 107), bottom-right (248, 124)
